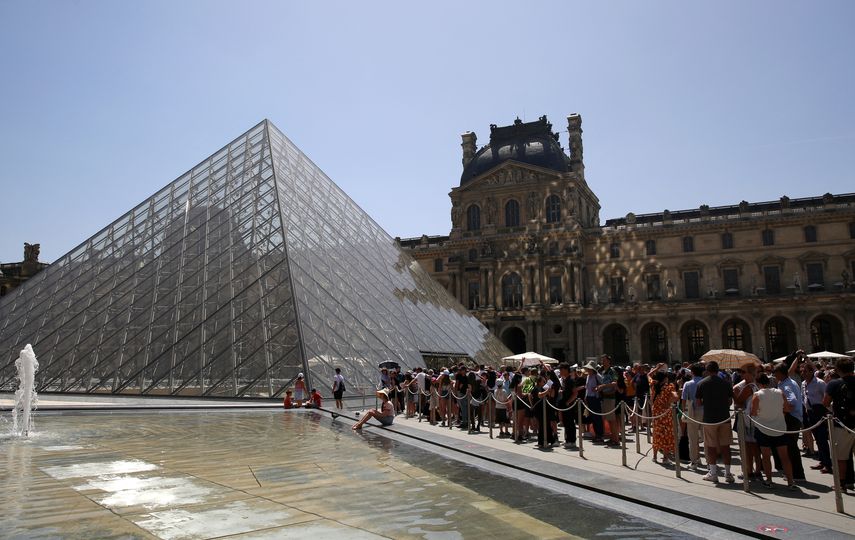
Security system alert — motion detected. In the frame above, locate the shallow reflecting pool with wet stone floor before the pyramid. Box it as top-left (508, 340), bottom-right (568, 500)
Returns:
top-left (0, 411), bottom-right (696, 540)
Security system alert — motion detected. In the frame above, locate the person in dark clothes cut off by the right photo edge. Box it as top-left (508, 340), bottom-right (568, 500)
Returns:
top-left (823, 358), bottom-right (855, 490)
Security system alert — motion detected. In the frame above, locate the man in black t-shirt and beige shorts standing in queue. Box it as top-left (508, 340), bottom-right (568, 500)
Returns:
top-left (695, 362), bottom-right (736, 484)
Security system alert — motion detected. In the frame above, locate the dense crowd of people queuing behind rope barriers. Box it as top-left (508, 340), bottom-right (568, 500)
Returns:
top-left (368, 350), bottom-right (855, 490)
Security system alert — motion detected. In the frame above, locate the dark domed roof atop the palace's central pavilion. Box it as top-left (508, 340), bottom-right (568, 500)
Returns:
top-left (460, 116), bottom-right (570, 186)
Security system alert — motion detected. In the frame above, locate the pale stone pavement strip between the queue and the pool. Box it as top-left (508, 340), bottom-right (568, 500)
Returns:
top-left (372, 415), bottom-right (855, 537)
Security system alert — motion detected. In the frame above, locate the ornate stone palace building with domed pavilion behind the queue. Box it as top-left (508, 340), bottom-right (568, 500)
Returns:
top-left (399, 114), bottom-right (855, 363)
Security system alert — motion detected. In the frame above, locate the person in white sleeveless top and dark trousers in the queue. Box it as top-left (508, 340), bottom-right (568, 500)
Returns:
top-left (751, 373), bottom-right (798, 490)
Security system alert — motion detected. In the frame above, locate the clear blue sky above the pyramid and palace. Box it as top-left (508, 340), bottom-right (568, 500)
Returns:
top-left (0, 0), bottom-right (855, 262)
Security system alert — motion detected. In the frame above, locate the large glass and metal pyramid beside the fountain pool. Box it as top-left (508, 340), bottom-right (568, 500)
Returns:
top-left (0, 120), bottom-right (509, 397)
